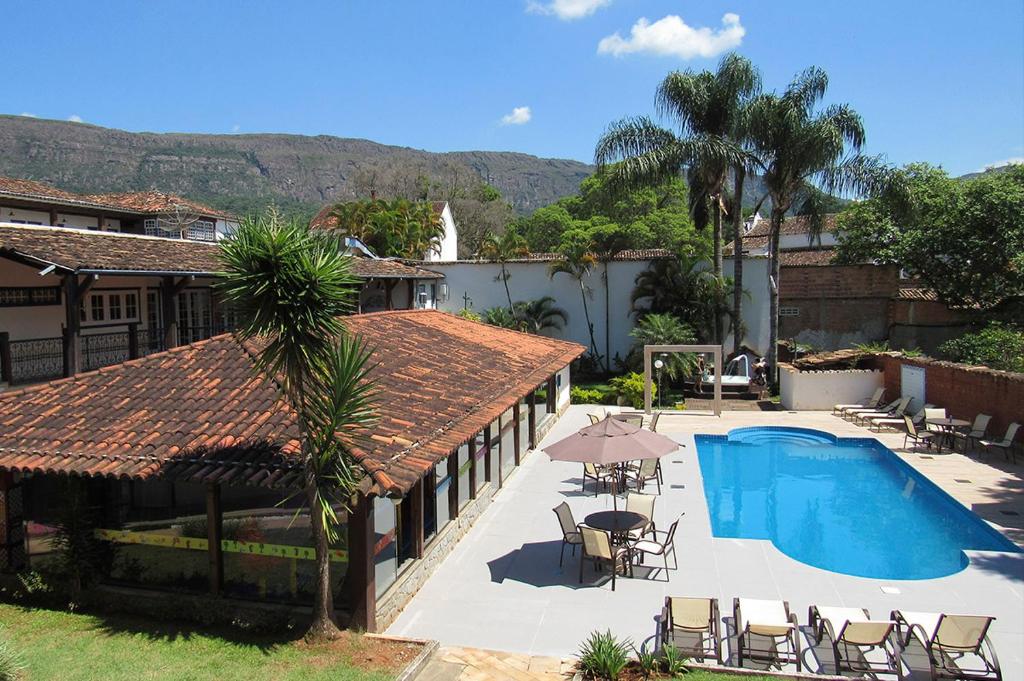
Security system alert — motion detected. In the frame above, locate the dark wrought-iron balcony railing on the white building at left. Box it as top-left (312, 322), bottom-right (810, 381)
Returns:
top-left (0, 325), bottom-right (229, 385)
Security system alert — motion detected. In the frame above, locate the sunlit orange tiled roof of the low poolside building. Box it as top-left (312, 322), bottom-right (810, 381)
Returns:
top-left (0, 310), bottom-right (584, 494)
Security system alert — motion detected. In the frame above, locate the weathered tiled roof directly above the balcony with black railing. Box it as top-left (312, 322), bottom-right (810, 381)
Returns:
top-left (0, 224), bottom-right (443, 279)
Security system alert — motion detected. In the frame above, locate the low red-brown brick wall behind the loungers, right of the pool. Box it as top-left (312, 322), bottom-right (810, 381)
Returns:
top-left (864, 354), bottom-right (1024, 437)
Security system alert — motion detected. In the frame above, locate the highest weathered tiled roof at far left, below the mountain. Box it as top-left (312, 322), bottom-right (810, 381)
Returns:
top-left (0, 176), bottom-right (237, 220)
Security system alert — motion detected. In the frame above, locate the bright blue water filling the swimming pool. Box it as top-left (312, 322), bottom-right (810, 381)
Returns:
top-left (696, 427), bottom-right (1020, 580)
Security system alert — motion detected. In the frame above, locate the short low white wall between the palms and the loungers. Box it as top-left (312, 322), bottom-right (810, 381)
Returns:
top-left (779, 364), bottom-right (885, 411)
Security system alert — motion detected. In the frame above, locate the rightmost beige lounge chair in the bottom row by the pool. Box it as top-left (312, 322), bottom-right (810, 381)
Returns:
top-left (892, 610), bottom-right (1002, 681)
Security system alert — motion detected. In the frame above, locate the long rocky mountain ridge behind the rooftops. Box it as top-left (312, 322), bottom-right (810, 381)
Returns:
top-left (0, 115), bottom-right (593, 215)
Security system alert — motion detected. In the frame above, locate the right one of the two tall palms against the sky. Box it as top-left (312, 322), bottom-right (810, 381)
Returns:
top-left (749, 67), bottom-right (889, 384)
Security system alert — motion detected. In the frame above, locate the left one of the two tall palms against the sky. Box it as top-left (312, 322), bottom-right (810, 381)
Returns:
top-left (595, 53), bottom-right (760, 342)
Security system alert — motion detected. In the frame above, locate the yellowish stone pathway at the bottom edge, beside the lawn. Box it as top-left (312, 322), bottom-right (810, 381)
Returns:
top-left (416, 646), bottom-right (575, 681)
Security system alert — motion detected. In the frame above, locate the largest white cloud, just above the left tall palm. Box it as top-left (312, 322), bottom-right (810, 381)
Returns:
top-left (597, 12), bottom-right (746, 59)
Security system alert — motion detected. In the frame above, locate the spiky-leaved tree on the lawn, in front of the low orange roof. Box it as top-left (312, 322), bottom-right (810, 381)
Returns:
top-left (217, 212), bottom-right (375, 640)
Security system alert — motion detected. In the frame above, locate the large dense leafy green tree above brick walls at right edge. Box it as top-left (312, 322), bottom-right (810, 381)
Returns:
top-left (837, 164), bottom-right (1024, 307)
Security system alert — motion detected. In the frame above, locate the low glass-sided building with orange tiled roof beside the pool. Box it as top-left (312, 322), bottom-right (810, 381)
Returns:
top-left (0, 310), bottom-right (584, 631)
